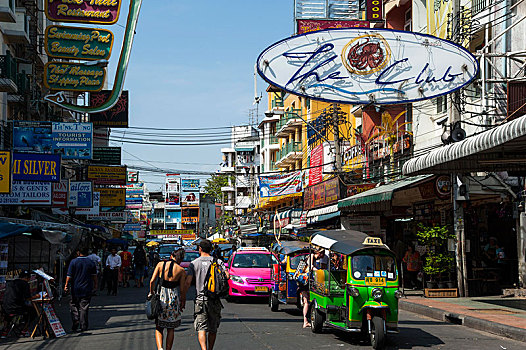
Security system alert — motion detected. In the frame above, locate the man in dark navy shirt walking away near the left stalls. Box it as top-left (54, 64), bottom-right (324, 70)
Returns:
top-left (64, 248), bottom-right (97, 332)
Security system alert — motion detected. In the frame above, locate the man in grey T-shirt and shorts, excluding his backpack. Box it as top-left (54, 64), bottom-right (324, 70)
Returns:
top-left (186, 239), bottom-right (230, 350)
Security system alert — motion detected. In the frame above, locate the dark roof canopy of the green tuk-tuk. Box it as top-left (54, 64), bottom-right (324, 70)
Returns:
top-left (311, 230), bottom-right (389, 255)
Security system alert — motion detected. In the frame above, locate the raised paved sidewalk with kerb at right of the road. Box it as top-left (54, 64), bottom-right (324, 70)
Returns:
top-left (399, 296), bottom-right (526, 342)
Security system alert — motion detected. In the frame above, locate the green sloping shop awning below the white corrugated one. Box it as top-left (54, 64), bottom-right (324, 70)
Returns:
top-left (338, 175), bottom-right (433, 209)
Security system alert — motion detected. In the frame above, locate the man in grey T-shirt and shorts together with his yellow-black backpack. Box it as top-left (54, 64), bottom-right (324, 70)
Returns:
top-left (186, 239), bottom-right (230, 350)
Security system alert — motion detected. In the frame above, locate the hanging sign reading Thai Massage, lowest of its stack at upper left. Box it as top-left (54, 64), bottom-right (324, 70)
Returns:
top-left (44, 62), bottom-right (106, 92)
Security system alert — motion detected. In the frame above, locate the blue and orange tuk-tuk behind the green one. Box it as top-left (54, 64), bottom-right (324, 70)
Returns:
top-left (269, 241), bottom-right (309, 311)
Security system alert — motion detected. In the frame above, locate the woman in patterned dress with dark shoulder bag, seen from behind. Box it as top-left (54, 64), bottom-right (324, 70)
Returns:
top-left (148, 248), bottom-right (186, 350)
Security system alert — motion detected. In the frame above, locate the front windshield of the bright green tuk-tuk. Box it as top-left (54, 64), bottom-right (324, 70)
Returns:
top-left (352, 255), bottom-right (396, 280)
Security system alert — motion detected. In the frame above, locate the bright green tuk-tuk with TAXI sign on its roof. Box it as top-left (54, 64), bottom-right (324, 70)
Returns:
top-left (309, 230), bottom-right (403, 349)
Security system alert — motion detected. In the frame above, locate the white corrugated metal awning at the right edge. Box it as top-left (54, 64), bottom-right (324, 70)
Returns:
top-left (402, 116), bottom-right (526, 175)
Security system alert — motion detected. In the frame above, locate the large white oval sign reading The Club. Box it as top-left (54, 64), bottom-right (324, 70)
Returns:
top-left (257, 28), bottom-right (478, 104)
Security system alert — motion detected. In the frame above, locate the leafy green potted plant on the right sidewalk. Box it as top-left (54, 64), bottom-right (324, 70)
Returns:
top-left (417, 224), bottom-right (455, 288)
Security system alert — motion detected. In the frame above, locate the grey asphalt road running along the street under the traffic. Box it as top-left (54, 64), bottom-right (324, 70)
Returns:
top-left (0, 288), bottom-right (526, 350)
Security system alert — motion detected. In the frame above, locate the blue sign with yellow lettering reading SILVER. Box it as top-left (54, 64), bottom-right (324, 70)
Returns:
top-left (13, 153), bottom-right (60, 182)
